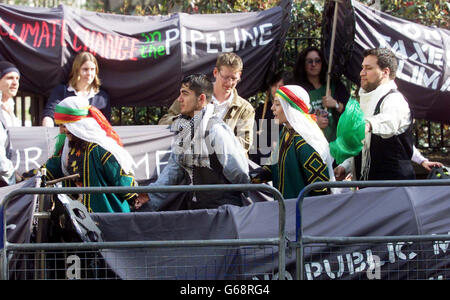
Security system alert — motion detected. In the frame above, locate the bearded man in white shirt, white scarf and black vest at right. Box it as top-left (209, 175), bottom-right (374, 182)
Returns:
top-left (335, 48), bottom-right (415, 180)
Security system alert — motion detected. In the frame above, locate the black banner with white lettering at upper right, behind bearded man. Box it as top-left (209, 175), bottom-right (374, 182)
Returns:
top-left (323, 0), bottom-right (450, 124)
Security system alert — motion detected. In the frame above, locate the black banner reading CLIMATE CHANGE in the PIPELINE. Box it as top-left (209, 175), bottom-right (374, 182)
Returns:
top-left (0, 0), bottom-right (291, 106)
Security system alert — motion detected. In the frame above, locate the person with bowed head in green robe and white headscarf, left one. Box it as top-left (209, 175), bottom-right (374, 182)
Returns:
top-left (45, 96), bottom-right (137, 212)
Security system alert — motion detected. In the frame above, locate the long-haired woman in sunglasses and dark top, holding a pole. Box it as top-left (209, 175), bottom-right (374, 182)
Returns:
top-left (294, 47), bottom-right (350, 142)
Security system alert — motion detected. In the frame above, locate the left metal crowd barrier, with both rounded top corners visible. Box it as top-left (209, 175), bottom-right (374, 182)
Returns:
top-left (0, 184), bottom-right (286, 280)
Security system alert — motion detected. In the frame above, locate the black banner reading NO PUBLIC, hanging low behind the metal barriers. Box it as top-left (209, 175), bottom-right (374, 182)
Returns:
top-left (85, 186), bottom-right (450, 280)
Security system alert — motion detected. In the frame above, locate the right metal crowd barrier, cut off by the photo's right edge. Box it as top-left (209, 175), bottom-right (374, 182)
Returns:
top-left (288, 179), bottom-right (450, 280)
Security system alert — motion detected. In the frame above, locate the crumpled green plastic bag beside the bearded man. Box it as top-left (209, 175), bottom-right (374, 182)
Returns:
top-left (330, 98), bottom-right (366, 164)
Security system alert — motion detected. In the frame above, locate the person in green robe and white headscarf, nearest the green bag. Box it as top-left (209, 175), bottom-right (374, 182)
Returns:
top-left (250, 85), bottom-right (334, 199)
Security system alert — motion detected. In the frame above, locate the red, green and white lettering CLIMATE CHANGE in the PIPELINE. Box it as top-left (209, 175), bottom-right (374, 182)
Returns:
top-left (0, 18), bottom-right (273, 61)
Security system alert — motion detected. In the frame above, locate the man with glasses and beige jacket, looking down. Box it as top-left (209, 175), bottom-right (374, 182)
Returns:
top-left (158, 53), bottom-right (255, 152)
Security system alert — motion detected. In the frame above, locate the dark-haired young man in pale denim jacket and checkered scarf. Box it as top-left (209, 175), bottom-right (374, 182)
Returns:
top-left (136, 74), bottom-right (250, 211)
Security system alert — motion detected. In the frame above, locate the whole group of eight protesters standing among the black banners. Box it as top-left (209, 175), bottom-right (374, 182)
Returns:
top-left (0, 47), bottom-right (442, 212)
